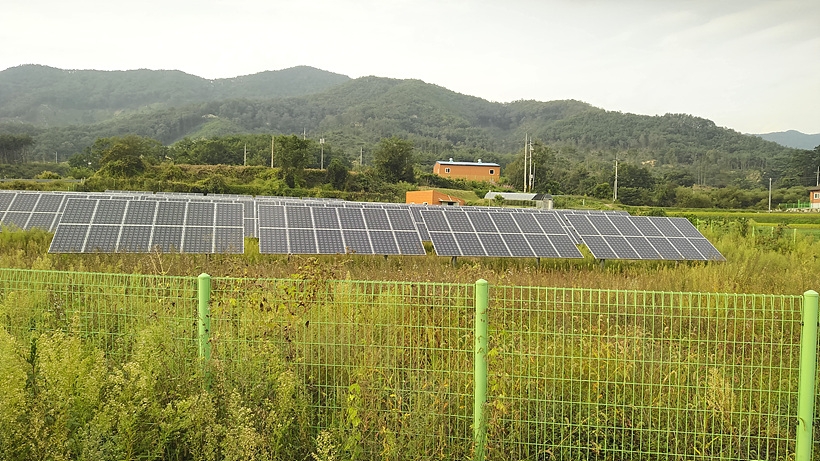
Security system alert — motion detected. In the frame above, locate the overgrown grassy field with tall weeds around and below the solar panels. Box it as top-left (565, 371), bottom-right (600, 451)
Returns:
top-left (0, 217), bottom-right (820, 461)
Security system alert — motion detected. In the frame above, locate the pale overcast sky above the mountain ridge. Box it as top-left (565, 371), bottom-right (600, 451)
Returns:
top-left (0, 0), bottom-right (820, 133)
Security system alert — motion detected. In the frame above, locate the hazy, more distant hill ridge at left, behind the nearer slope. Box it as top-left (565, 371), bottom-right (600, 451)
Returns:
top-left (0, 65), bottom-right (350, 126)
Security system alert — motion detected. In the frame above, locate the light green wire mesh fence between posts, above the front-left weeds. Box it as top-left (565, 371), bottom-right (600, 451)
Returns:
top-left (0, 269), bottom-right (818, 460)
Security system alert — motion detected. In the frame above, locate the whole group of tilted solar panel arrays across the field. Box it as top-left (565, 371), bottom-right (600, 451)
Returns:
top-left (0, 190), bottom-right (725, 261)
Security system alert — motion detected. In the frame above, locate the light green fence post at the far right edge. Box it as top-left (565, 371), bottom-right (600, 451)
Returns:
top-left (795, 290), bottom-right (818, 461)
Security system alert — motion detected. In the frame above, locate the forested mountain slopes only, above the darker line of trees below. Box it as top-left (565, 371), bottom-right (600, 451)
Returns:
top-left (0, 66), bottom-right (808, 186)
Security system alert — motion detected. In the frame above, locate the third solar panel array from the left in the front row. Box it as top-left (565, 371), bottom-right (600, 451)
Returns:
top-left (420, 208), bottom-right (583, 258)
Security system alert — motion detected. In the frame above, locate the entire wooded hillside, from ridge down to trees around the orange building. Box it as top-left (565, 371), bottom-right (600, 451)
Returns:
top-left (0, 66), bottom-right (820, 208)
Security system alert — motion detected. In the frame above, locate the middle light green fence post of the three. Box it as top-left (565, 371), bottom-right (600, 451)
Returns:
top-left (473, 279), bottom-right (489, 461)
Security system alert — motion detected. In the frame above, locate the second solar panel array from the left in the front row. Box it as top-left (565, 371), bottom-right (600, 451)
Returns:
top-left (257, 203), bottom-right (425, 255)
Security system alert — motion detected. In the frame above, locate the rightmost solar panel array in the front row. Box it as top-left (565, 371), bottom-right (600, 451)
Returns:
top-left (565, 214), bottom-right (726, 261)
